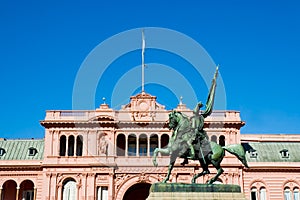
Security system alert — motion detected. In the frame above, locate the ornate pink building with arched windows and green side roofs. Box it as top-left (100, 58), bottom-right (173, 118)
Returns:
top-left (0, 93), bottom-right (300, 200)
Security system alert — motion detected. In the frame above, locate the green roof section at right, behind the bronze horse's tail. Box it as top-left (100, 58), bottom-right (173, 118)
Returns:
top-left (246, 142), bottom-right (300, 162)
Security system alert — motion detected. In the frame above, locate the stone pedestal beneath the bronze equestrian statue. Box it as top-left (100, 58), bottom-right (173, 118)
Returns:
top-left (147, 183), bottom-right (247, 200)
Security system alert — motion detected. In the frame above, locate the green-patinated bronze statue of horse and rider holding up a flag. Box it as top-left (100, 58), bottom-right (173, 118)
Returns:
top-left (153, 67), bottom-right (248, 184)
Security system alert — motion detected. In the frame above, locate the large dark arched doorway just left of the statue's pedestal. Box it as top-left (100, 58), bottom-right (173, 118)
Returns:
top-left (123, 183), bottom-right (151, 200)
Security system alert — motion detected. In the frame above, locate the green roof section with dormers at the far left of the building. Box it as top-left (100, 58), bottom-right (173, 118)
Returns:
top-left (0, 139), bottom-right (44, 160)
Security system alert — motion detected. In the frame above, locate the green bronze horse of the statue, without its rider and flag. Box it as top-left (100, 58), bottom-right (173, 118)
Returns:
top-left (152, 111), bottom-right (249, 184)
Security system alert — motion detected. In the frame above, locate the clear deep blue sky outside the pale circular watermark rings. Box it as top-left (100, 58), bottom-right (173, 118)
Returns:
top-left (0, 0), bottom-right (300, 138)
